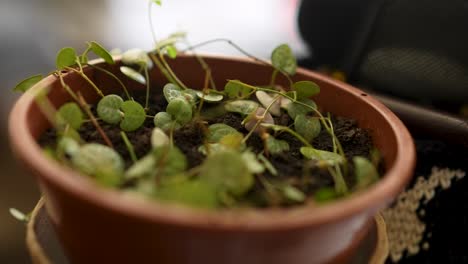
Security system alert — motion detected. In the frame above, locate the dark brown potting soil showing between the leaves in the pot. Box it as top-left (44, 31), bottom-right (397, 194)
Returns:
top-left (39, 91), bottom-right (373, 207)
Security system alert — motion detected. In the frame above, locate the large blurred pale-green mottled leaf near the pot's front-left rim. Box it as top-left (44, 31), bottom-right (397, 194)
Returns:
top-left (71, 143), bottom-right (124, 186)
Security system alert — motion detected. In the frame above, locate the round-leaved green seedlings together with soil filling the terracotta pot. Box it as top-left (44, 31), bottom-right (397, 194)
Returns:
top-left (15, 1), bottom-right (379, 208)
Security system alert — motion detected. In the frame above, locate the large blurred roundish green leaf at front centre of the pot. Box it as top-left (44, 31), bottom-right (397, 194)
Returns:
top-left (199, 151), bottom-right (254, 196)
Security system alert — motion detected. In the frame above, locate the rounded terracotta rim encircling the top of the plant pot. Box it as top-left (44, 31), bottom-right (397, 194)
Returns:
top-left (9, 55), bottom-right (416, 231)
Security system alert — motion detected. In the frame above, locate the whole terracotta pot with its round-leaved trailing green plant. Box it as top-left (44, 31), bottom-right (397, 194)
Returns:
top-left (10, 2), bottom-right (415, 263)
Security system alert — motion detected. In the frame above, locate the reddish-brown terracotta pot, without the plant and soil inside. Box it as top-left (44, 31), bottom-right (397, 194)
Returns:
top-left (9, 56), bottom-right (415, 264)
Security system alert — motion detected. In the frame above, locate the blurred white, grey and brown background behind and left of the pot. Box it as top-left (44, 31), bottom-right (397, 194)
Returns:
top-left (0, 0), bottom-right (307, 263)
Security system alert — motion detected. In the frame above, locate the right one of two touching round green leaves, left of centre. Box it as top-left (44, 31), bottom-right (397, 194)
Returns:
top-left (120, 101), bottom-right (146, 131)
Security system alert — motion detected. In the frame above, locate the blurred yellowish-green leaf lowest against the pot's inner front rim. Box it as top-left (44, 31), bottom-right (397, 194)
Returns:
top-left (155, 180), bottom-right (219, 209)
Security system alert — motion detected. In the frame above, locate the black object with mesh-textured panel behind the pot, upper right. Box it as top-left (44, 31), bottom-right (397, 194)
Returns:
top-left (298, 0), bottom-right (468, 104)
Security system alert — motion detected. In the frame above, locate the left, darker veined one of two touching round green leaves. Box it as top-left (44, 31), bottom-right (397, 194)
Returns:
top-left (97, 94), bottom-right (124, 124)
